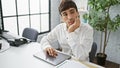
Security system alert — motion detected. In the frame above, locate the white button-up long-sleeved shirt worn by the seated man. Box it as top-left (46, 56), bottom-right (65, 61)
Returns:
top-left (41, 23), bottom-right (93, 60)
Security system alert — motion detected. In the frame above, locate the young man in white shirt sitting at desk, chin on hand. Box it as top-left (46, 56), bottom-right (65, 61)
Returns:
top-left (41, 0), bottom-right (93, 60)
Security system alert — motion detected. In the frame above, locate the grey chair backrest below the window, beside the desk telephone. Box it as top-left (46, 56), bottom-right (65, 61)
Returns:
top-left (22, 28), bottom-right (39, 42)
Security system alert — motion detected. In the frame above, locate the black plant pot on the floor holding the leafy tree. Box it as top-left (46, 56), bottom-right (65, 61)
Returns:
top-left (97, 53), bottom-right (107, 66)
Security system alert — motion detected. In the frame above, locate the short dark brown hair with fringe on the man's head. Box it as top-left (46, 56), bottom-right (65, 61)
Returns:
top-left (59, 0), bottom-right (78, 14)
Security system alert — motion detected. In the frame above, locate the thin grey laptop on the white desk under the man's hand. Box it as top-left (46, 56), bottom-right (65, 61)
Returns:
top-left (33, 51), bottom-right (71, 66)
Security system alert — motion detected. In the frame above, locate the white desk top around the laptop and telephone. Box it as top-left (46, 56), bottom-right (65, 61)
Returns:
top-left (0, 39), bottom-right (104, 68)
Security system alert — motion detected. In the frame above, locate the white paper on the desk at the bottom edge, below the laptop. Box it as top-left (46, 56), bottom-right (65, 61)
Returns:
top-left (56, 60), bottom-right (89, 68)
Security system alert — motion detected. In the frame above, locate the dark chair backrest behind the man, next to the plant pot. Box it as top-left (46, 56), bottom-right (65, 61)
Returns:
top-left (89, 42), bottom-right (97, 62)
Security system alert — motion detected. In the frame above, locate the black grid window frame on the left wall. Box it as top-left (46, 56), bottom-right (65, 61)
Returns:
top-left (0, 0), bottom-right (51, 35)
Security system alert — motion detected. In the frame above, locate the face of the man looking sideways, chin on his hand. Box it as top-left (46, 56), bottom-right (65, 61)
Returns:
top-left (61, 8), bottom-right (79, 28)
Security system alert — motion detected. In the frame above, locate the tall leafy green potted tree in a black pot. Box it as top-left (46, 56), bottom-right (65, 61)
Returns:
top-left (83, 0), bottom-right (120, 65)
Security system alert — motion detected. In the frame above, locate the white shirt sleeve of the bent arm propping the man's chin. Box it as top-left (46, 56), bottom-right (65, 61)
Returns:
top-left (67, 28), bottom-right (93, 60)
